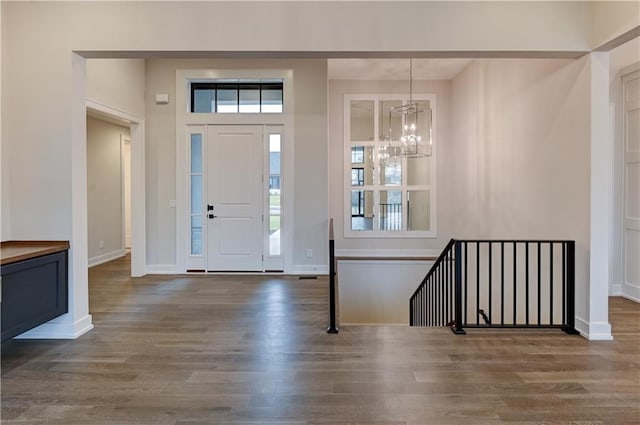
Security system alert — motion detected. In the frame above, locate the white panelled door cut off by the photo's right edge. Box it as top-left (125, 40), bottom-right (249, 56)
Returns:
top-left (622, 71), bottom-right (640, 300)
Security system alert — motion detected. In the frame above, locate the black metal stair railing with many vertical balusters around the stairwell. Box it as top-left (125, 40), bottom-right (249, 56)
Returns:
top-left (409, 239), bottom-right (577, 334)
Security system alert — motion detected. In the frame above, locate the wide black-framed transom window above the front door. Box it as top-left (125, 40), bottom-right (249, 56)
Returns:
top-left (190, 79), bottom-right (283, 114)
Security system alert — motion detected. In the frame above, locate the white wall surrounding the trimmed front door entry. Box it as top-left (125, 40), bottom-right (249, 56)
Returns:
top-left (146, 59), bottom-right (328, 271)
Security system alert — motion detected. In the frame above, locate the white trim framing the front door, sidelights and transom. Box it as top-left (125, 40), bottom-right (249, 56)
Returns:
top-left (176, 69), bottom-right (295, 274)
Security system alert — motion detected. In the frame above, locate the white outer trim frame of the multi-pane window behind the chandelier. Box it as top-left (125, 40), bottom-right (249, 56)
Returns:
top-left (343, 93), bottom-right (438, 239)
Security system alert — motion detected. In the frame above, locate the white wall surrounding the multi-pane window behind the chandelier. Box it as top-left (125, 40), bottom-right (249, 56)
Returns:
top-left (329, 80), bottom-right (455, 256)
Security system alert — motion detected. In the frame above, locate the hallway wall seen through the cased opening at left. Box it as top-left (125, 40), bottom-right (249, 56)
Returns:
top-left (87, 117), bottom-right (129, 266)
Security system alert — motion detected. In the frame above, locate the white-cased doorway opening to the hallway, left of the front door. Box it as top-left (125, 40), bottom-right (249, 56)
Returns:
top-left (87, 100), bottom-right (145, 277)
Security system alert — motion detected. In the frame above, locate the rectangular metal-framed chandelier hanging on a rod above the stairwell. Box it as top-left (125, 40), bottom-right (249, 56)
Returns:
top-left (384, 58), bottom-right (432, 159)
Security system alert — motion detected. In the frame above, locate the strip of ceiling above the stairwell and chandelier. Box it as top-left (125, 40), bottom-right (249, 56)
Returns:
top-left (328, 58), bottom-right (473, 80)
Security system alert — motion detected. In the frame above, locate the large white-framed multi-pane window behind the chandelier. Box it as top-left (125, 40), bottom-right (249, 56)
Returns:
top-left (344, 94), bottom-right (437, 238)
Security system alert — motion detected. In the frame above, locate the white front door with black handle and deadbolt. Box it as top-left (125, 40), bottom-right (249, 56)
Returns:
top-left (205, 125), bottom-right (264, 271)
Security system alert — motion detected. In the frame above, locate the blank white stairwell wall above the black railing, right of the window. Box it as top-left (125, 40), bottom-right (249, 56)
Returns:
top-left (452, 59), bottom-right (601, 334)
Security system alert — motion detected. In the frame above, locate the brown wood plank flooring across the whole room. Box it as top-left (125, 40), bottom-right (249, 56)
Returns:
top-left (0, 255), bottom-right (640, 425)
